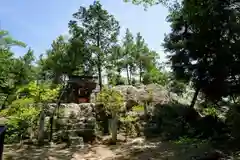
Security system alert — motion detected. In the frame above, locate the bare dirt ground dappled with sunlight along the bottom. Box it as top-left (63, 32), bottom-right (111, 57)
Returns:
top-left (1, 138), bottom-right (227, 160)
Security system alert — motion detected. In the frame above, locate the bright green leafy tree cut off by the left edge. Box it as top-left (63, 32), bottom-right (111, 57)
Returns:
top-left (0, 30), bottom-right (26, 108)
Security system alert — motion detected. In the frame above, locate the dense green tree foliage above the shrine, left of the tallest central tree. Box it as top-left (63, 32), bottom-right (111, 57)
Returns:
top-left (38, 34), bottom-right (92, 84)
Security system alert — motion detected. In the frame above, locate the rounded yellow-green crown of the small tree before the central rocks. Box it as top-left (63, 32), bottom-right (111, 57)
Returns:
top-left (96, 88), bottom-right (124, 116)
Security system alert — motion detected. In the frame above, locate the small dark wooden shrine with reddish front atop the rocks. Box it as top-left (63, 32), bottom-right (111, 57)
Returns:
top-left (61, 76), bottom-right (97, 103)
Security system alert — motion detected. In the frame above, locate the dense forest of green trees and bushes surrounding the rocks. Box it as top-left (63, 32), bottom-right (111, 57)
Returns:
top-left (0, 0), bottom-right (240, 159)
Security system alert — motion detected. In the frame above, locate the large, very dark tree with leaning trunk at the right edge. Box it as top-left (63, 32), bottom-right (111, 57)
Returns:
top-left (164, 0), bottom-right (240, 107)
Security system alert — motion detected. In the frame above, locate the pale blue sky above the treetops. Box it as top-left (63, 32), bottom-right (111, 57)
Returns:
top-left (0, 0), bottom-right (170, 61)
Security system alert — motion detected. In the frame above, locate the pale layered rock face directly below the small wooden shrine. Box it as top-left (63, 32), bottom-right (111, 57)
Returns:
top-left (54, 103), bottom-right (96, 142)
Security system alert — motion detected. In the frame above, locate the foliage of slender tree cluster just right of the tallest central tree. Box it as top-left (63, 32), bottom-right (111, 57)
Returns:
top-left (107, 29), bottom-right (159, 85)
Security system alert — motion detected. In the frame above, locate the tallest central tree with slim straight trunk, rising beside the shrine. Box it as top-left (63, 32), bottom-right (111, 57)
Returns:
top-left (70, 1), bottom-right (120, 89)
